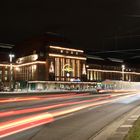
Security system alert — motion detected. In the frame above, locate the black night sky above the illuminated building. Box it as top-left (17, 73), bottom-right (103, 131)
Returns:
top-left (0, 0), bottom-right (140, 51)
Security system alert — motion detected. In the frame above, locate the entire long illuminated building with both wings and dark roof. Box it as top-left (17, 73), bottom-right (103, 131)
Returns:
top-left (0, 37), bottom-right (140, 90)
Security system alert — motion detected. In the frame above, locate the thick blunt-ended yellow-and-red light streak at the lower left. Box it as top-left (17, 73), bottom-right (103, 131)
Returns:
top-left (0, 113), bottom-right (54, 138)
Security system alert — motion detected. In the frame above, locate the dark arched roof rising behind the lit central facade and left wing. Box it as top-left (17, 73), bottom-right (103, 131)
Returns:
top-left (14, 33), bottom-right (71, 57)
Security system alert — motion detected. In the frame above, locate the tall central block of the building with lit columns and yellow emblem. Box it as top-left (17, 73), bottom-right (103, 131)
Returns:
top-left (47, 46), bottom-right (86, 81)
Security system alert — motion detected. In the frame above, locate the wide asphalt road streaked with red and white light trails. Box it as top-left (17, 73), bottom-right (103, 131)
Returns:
top-left (0, 93), bottom-right (140, 140)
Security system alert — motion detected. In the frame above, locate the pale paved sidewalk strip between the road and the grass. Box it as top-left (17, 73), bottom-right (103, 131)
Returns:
top-left (90, 106), bottom-right (140, 140)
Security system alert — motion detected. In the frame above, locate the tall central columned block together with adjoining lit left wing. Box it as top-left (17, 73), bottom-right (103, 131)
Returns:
top-left (15, 46), bottom-right (86, 81)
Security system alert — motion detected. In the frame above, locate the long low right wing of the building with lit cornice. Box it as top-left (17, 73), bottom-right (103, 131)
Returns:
top-left (87, 57), bottom-right (140, 82)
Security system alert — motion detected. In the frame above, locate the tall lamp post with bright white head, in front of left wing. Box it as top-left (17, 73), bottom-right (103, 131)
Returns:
top-left (9, 54), bottom-right (15, 90)
